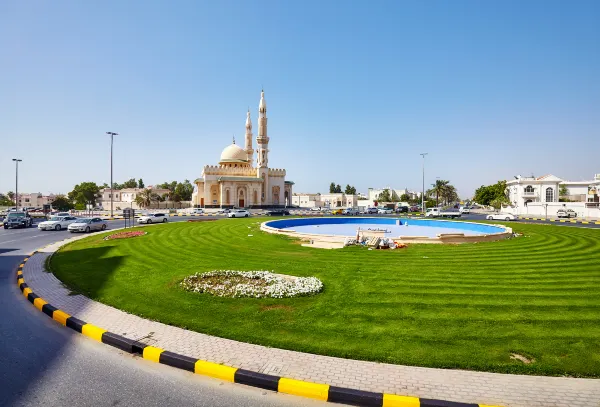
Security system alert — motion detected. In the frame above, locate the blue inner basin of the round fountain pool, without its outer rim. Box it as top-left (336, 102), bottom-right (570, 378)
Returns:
top-left (267, 217), bottom-right (505, 238)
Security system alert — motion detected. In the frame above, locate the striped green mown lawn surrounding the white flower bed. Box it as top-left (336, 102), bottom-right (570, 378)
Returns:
top-left (51, 222), bottom-right (600, 377)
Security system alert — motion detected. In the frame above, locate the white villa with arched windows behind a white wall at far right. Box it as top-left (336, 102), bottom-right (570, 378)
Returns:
top-left (502, 174), bottom-right (600, 217)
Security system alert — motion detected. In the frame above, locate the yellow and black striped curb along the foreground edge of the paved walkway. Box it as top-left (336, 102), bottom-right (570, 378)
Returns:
top-left (17, 252), bottom-right (498, 407)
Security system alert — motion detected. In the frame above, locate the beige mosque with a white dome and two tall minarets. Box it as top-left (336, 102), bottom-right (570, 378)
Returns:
top-left (192, 91), bottom-right (294, 208)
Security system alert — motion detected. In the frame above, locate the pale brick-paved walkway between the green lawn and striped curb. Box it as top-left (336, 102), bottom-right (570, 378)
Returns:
top-left (23, 242), bottom-right (600, 407)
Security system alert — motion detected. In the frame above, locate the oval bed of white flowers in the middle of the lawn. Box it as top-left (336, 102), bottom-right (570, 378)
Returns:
top-left (181, 270), bottom-right (323, 298)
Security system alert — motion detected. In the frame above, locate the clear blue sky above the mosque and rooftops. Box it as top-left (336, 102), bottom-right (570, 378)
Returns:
top-left (0, 0), bottom-right (600, 196)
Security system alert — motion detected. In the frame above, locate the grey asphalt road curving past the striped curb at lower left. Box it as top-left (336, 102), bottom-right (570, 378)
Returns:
top-left (0, 217), bottom-right (325, 407)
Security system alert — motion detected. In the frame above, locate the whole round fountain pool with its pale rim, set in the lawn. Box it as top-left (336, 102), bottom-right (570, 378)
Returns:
top-left (261, 217), bottom-right (512, 243)
